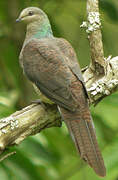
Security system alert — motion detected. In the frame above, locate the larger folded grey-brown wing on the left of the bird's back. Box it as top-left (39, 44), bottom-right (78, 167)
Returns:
top-left (22, 38), bottom-right (78, 111)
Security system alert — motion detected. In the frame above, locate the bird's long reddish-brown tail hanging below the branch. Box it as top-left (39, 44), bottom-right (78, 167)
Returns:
top-left (60, 107), bottom-right (106, 177)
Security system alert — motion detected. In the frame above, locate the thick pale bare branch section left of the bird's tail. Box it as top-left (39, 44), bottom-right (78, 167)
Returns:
top-left (0, 104), bottom-right (61, 153)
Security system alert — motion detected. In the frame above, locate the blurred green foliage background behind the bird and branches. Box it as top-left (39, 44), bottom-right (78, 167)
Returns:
top-left (0, 0), bottom-right (118, 180)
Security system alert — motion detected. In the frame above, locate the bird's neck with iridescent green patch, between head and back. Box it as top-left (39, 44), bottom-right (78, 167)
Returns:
top-left (25, 20), bottom-right (53, 42)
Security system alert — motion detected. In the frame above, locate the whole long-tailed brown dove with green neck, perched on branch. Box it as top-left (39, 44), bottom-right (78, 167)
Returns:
top-left (16, 7), bottom-right (106, 177)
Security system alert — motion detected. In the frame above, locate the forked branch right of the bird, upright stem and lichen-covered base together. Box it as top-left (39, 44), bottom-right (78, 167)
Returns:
top-left (81, 0), bottom-right (118, 104)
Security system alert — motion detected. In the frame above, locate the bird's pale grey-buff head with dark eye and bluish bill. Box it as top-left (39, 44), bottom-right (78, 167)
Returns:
top-left (16, 7), bottom-right (47, 24)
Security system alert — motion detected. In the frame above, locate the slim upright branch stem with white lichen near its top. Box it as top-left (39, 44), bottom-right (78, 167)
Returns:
top-left (87, 0), bottom-right (106, 75)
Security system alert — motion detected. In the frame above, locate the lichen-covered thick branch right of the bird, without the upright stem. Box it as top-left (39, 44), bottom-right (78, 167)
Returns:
top-left (83, 56), bottom-right (118, 104)
